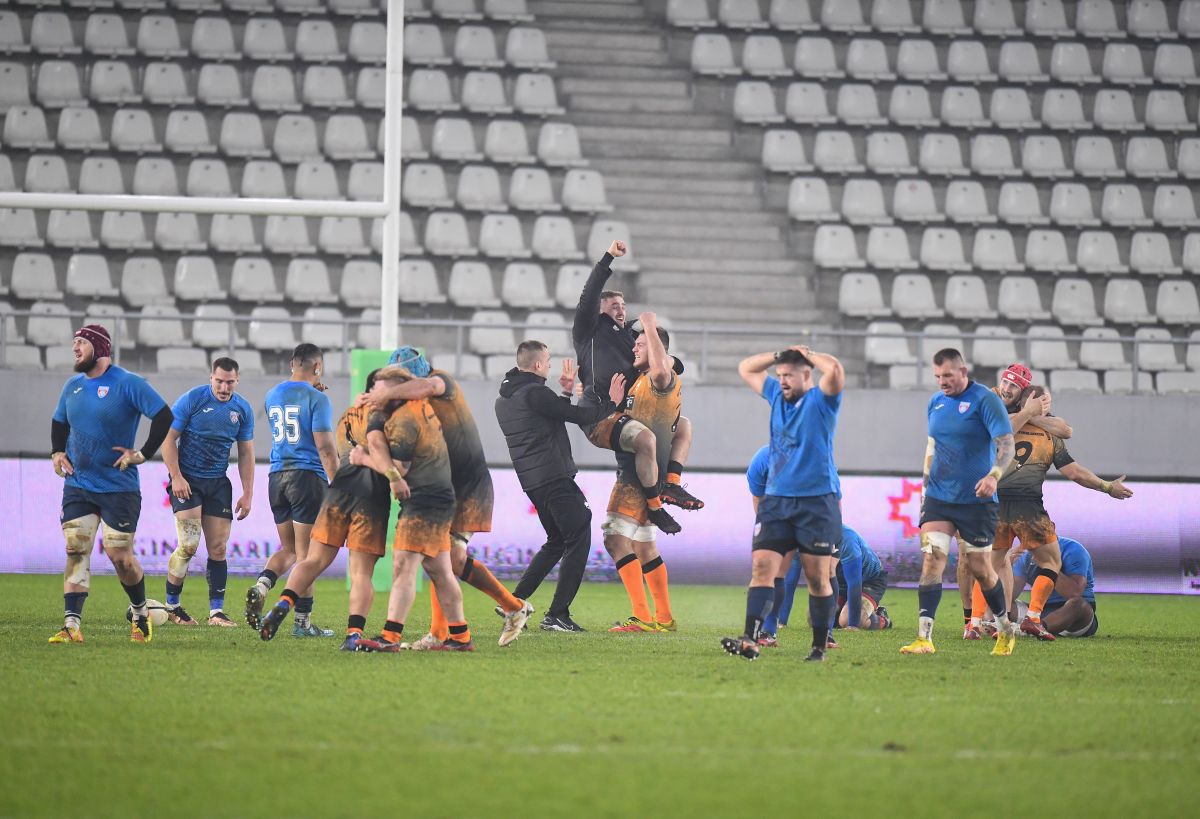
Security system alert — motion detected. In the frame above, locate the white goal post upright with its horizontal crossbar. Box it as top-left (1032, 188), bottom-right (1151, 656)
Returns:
top-left (0, 0), bottom-right (404, 349)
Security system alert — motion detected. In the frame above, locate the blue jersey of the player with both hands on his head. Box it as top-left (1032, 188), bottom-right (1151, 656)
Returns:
top-left (762, 376), bottom-right (840, 497)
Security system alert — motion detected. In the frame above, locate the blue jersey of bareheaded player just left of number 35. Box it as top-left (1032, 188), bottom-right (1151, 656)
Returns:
top-left (170, 384), bottom-right (254, 478)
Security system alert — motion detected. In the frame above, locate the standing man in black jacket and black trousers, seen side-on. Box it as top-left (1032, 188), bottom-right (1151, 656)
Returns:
top-left (496, 340), bottom-right (625, 632)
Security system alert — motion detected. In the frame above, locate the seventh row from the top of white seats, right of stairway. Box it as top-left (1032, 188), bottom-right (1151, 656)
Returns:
top-left (838, 273), bottom-right (1200, 326)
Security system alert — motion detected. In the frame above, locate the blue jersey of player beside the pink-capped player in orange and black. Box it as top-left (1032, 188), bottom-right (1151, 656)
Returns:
top-left (925, 381), bottom-right (1013, 503)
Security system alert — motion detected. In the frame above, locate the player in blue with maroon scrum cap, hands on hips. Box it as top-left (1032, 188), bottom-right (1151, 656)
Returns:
top-left (49, 324), bottom-right (172, 642)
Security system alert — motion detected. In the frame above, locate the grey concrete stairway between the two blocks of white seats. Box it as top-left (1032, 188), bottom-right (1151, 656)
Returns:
top-left (529, 0), bottom-right (824, 382)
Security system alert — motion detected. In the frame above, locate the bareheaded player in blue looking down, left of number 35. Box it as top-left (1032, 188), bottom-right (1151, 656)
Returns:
top-left (162, 358), bottom-right (254, 628)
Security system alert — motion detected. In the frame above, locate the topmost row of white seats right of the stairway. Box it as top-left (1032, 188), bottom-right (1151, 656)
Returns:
top-left (667, 0), bottom-right (1200, 40)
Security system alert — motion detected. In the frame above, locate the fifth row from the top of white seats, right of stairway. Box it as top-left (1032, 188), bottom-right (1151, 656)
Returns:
top-left (787, 177), bottom-right (1200, 228)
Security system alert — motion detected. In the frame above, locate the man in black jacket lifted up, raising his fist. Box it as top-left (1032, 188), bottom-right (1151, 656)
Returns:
top-left (571, 241), bottom-right (704, 533)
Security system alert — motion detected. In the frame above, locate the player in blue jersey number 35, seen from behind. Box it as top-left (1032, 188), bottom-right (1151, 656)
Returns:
top-left (246, 343), bottom-right (337, 636)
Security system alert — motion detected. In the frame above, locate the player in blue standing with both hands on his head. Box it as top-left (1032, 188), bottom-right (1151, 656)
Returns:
top-left (721, 346), bottom-right (846, 662)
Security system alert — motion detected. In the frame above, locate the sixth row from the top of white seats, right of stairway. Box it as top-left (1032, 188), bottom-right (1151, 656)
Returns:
top-left (812, 225), bottom-right (1200, 276)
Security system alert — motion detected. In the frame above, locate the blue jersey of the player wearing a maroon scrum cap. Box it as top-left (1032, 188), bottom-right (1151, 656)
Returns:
top-left (54, 365), bottom-right (167, 492)
